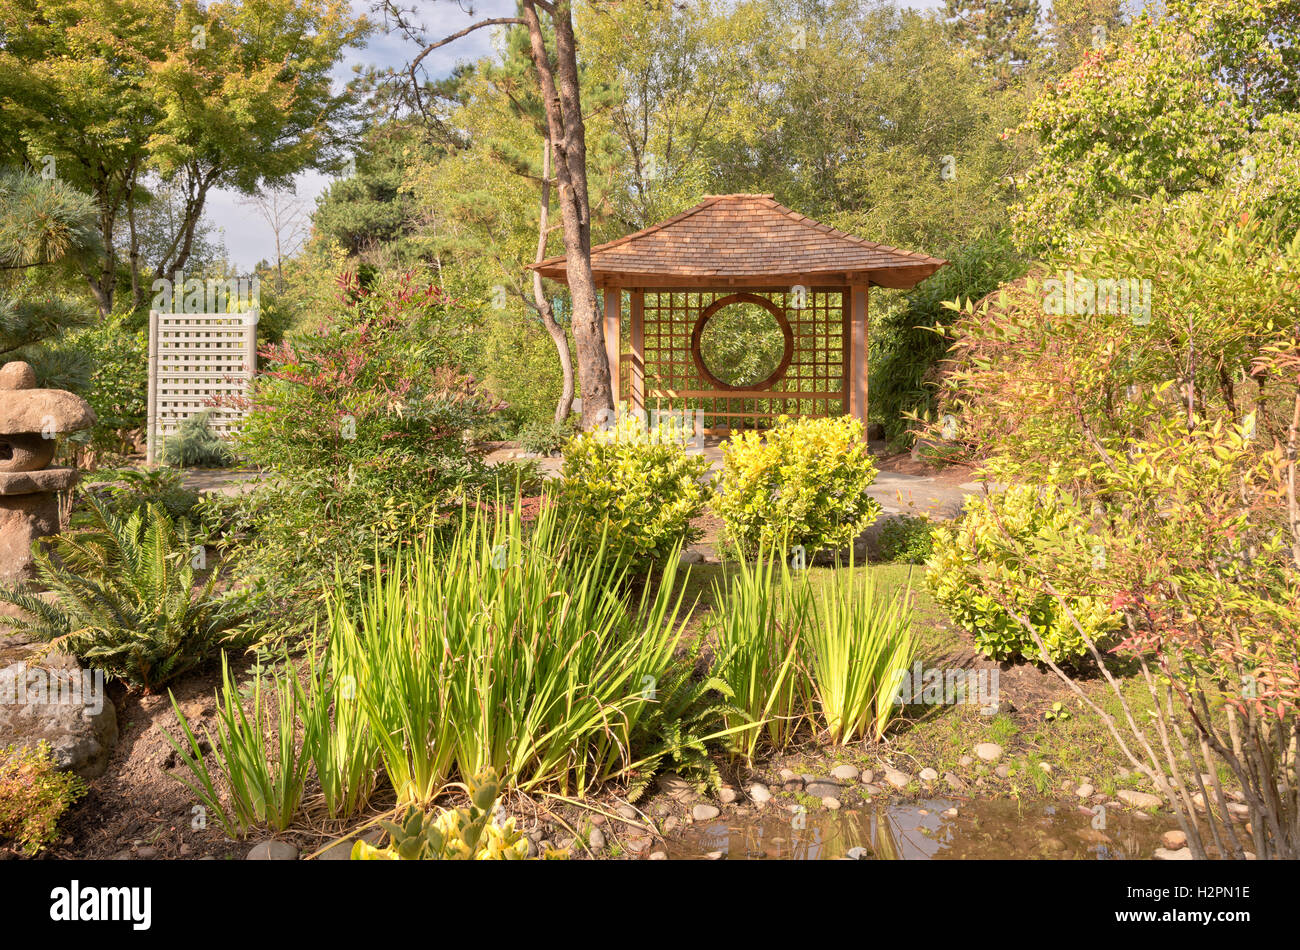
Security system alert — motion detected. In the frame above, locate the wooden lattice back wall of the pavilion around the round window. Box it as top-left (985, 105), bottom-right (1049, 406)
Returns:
top-left (637, 290), bottom-right (849, 433)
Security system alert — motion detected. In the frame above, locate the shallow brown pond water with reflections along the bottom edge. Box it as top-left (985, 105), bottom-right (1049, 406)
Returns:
top-left (666, 798), bottom-right (1167, 860)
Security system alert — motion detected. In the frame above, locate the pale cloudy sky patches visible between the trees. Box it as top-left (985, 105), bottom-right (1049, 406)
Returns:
top-left (204, 0), bottom-right (943, 273)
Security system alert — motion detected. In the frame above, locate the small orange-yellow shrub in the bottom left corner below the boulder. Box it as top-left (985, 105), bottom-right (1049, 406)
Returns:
top-left (0, 742), bottom-right (86, 855)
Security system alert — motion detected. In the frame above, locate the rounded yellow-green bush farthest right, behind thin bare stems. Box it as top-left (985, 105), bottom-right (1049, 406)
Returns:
top-left (926, 486), bottom-right (1119, 663)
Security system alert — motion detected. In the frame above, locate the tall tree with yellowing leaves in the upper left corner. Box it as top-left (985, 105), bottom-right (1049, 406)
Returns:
top-left (0, 0), bottom-right (368, 313)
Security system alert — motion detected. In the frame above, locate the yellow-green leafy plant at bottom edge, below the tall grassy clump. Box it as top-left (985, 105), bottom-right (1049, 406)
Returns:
top-left (352, 769), bottom-right (538, 860)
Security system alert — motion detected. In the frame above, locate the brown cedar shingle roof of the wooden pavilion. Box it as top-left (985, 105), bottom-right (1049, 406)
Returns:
top-left (533, 195), bottom-right (948, 287)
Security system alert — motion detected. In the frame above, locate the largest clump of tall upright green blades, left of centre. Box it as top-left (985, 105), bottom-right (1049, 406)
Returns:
top-left (329, 503), bottom-right (681, 803)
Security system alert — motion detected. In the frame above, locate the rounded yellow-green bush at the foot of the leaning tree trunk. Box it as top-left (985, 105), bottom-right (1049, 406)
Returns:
top-left (558, 415), bottom-right (709, 569)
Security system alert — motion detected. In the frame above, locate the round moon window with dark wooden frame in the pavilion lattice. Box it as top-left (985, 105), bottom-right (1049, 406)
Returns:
top-left (690, 294), bottom-right (794, 390)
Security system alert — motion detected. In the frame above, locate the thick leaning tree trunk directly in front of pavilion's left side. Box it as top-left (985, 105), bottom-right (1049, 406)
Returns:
top-left (520, 0), bottom-right (614, 428)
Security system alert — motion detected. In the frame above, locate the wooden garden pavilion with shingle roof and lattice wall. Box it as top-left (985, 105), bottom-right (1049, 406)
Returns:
top-left (533, 195), bottom-right (946, 434)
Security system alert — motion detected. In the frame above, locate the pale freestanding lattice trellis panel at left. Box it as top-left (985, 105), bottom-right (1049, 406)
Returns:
top-left (148, 311), bottom-right (257, 464)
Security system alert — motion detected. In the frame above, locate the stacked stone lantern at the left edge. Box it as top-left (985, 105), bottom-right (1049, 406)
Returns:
top-left (0, 361), bottom-right (95, 584)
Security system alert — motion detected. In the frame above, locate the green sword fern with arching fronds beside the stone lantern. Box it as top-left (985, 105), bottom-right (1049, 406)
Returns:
top-left (0, 499), bottom-right (247, 691)
